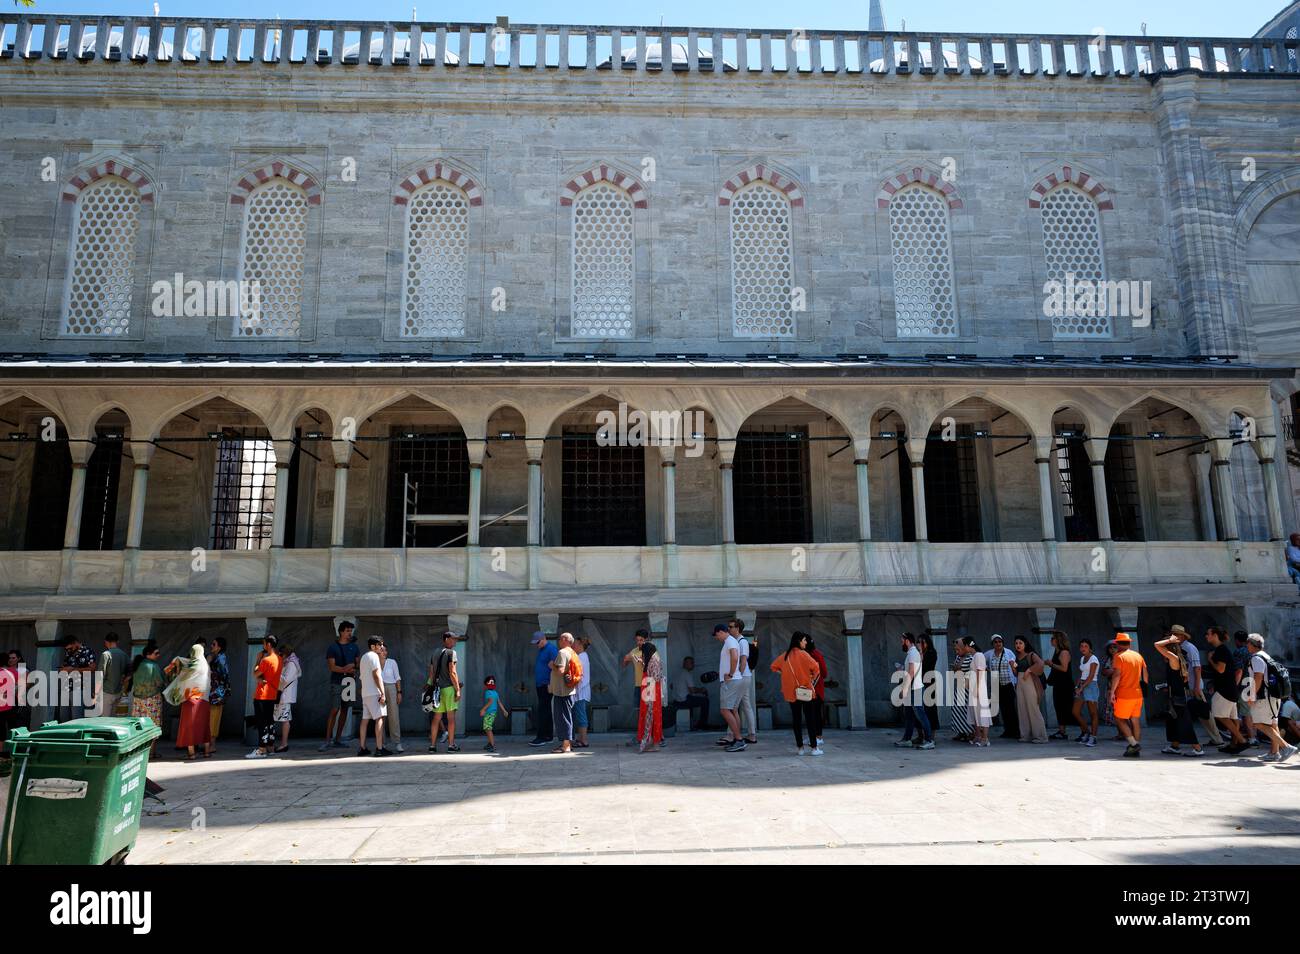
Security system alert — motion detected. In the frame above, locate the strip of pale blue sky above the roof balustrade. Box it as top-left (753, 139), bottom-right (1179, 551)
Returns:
top-left (15, 0), bottom-right (1286, 36)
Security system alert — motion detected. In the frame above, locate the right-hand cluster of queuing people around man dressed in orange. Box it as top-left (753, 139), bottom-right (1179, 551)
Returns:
top-left (894, 625), bottom-right (1300, 762)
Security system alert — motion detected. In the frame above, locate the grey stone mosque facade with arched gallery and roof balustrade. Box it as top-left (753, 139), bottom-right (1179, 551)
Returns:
top-left (0, 14), bottom-right (1300, 728)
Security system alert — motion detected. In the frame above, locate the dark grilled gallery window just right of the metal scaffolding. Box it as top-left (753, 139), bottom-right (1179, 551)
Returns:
top-left (560, 426), bottom-right (646, 547)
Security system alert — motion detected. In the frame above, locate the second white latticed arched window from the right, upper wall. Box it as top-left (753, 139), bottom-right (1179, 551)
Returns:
top-left (889, 186), bottom-right (959, 338)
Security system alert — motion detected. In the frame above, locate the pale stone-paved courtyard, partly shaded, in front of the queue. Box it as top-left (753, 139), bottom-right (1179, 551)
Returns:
top-left (129, 728), bottom-right (1300, 864)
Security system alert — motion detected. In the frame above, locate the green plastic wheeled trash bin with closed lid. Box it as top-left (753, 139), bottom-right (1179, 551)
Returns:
top-left (0, 717), bottom-right (163, 864)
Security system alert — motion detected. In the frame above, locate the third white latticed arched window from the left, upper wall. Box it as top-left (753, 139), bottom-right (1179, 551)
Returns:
top-left (402, 182), bottom-right (469, 338)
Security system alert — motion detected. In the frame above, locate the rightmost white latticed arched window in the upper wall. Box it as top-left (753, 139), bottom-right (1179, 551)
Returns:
top-left (1043, 186), bottom-right (1110, 338)
